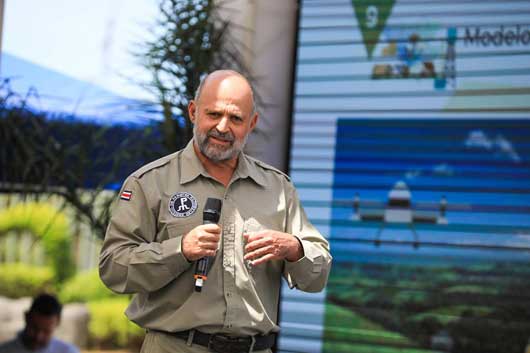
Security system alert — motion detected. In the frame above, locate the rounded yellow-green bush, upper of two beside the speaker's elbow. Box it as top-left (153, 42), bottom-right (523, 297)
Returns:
top-left (59, 269), bottom-right (116, 303)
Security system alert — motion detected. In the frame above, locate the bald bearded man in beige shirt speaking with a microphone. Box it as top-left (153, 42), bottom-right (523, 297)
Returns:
top-left (100, 70), bottom-right (331, 353)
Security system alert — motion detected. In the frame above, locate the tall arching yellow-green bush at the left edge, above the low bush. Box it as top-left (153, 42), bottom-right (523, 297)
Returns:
top-left (0, 202), bottom-right (74, 283)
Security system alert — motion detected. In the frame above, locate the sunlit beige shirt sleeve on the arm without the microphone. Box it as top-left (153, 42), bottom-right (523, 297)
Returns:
top-left (283, 185), bottom-right (332, 292)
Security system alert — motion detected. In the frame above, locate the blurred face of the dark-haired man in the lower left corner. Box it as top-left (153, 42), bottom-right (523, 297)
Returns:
top-left (23, 313), bottom-right (59, 350)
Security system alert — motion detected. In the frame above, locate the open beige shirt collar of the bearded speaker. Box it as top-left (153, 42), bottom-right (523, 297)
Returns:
top-left (180, 139), bottom-right (266, 186)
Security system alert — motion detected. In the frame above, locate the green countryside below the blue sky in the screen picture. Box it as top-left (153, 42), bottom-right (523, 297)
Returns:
top-left (324, 262), bottom-right (530, 353)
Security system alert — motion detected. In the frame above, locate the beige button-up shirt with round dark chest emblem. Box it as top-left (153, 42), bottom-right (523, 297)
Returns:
top-left (99, 142), bottom-right (331, 335)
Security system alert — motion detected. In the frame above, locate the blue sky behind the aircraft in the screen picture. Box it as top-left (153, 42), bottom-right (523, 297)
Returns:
top-left (331, 119), bottom-right (530, 263)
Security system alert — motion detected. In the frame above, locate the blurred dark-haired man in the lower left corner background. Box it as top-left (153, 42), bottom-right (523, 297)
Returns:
top-left (0, 294), bottom-right (79, 353)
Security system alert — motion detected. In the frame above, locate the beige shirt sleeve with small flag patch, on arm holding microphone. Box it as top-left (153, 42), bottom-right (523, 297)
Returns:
top-left (99, 176), bottom-right (191, 293)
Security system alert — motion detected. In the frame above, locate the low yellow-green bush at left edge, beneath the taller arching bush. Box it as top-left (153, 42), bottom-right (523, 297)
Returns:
top-left (0, 263), bottom-right (54, 298)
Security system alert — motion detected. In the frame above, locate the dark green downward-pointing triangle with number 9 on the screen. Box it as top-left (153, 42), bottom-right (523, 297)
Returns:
top-left (352, 0), bottom-right (396, 58)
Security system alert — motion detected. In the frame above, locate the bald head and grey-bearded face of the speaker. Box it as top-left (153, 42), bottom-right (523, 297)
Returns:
top-left (189, 74), bottom-right (258, 163)
